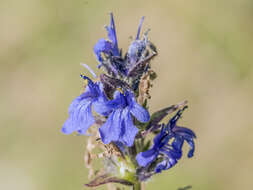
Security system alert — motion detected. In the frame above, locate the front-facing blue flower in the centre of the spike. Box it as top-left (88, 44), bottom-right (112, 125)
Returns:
top-left (99, 91), bottom-right (150, 146)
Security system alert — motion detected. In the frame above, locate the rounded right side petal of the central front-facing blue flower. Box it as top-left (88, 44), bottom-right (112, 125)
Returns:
top-left (126, 92), bottom-right (150, 123)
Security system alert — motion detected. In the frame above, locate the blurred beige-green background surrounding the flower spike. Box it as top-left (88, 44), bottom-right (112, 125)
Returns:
top-left (0, 0), bottom-right (253, 190)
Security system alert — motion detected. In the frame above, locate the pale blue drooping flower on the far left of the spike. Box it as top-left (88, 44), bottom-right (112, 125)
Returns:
top-left (62, 75), bottom-right (108, 134)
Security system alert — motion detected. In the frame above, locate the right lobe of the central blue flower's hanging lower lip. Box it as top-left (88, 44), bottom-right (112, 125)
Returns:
top-left (119, 109), bottom-right (138, 147)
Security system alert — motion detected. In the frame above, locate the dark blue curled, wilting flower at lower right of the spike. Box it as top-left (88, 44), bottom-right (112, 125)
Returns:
top-left (136, 108), bottom-right (196, 173)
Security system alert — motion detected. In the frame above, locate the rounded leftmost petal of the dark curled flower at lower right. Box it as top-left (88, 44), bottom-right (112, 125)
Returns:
top-left (136, 149), bottom-right (158, 167)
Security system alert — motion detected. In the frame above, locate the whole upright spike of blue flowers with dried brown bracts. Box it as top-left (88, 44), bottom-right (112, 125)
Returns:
top-left (62, 14), bottom-right (196, 189)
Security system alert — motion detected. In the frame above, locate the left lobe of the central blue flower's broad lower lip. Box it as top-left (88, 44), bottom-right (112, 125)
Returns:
top-left (99, 110), bottom-right (122, 144)
